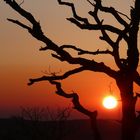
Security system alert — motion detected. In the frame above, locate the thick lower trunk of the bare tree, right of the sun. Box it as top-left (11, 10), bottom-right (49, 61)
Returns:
top-left (117, 75), bottom-right (136, 140)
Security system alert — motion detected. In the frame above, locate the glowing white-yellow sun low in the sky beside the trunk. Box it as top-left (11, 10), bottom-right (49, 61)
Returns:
top-left (103, 95), bottom-right (118, 109)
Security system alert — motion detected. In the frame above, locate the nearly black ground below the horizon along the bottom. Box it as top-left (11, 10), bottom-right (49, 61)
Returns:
top-left (0, 118), bottom-right (140, 140)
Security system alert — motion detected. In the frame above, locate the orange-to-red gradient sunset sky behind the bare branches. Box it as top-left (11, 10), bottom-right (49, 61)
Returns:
top-left (0, 0), bottom-right (140, 118)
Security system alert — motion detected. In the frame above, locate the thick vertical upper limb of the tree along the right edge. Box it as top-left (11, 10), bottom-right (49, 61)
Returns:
top-left (127, 0), bottom-right (140, 71)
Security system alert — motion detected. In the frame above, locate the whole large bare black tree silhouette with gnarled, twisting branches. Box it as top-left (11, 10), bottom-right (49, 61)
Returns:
top-left (4, 0), bottom-right (140, 140)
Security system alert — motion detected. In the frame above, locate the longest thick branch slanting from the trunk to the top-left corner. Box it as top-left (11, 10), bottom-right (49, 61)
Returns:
top-left (5, 0), bottom-right (116, 80)
